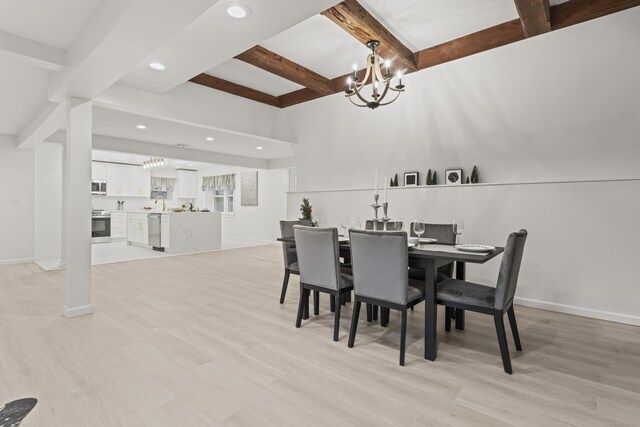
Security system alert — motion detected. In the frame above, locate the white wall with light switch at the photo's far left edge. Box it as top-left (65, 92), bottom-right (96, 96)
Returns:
top-left (0, 137), bottom-right (35, 264)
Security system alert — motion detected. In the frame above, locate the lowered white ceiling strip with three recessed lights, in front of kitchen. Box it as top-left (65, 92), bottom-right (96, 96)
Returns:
top-left (93, 107), bottom-right (293, 160)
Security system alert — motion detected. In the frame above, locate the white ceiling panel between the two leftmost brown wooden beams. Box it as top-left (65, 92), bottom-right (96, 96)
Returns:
top-left (207, 59), bottom-right (304, 96)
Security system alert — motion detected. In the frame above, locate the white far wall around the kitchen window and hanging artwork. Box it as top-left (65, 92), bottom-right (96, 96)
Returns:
top-left (197, 166), bottom-right (288, 243)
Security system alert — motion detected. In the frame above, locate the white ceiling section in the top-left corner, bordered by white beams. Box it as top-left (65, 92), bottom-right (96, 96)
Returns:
top-left (0, 0), bottom-right (100, 49)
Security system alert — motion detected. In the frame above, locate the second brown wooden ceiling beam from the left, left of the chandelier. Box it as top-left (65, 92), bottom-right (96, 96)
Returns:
top-left (236, 46), bottom-right (334, 95)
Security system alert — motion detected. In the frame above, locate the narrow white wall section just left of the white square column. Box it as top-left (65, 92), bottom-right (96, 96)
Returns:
top-left (35, 142), bottom-right (63, 265)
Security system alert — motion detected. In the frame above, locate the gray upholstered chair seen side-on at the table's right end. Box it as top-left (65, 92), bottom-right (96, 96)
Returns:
top-left (438, 229), bottom-right (527, 374)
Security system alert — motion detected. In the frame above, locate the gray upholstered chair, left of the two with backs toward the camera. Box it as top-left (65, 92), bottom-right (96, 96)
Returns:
top-left (293, 225), bottom-right (353, 341)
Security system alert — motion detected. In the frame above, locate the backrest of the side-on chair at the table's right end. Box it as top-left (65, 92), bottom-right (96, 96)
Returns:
top-left (493, 229), bottom-right (528, 310)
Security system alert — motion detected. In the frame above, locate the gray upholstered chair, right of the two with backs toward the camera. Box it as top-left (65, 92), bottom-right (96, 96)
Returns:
top-left (349, 230), bottom-right (424, 366)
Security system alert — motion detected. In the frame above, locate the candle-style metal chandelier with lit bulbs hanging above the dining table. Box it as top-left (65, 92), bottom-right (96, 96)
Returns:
top-left (344, 40), bottom-right (404, 110)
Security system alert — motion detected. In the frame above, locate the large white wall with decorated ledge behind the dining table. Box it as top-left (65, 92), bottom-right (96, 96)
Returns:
top-left (285, 8), bottom-right (640, 324)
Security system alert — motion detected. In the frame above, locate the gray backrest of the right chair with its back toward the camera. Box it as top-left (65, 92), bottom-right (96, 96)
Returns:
top-left (349, 230), bottom-right (409, 304)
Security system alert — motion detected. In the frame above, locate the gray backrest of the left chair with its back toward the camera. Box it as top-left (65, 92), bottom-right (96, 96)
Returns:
top-left (293, 225), bottom-right (340, 290)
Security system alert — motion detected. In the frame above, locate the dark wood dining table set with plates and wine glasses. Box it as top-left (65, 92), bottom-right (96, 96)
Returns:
top-left (278, 237), bottom-right (504, 360)
